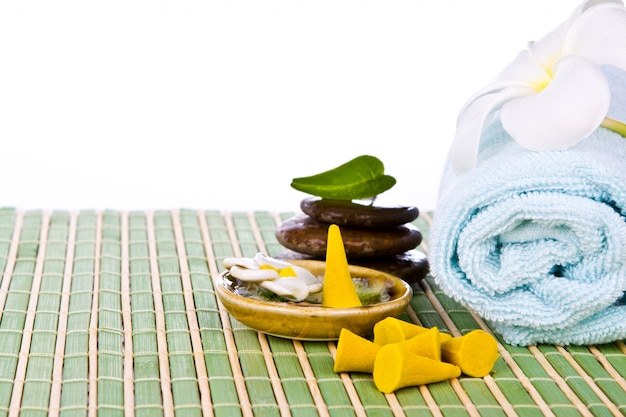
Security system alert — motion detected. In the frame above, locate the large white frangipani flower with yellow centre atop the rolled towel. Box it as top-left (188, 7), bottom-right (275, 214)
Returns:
top-left (451, 0), bottom-right (626, 174)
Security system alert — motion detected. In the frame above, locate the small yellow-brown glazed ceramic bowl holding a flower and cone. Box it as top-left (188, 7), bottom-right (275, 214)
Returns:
top-left (215, 260), bottom-right (413, 340)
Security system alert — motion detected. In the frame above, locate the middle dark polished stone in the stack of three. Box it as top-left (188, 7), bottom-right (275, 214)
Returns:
top-left (276, 214), bottom-right (422, 258)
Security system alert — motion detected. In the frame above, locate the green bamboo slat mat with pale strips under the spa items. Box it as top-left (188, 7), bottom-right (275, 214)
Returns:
top-left (0, 208), bottom-right (626, 417)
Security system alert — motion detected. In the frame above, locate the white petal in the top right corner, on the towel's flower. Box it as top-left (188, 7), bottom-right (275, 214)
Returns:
top-left (563, 2), bottom-right (626, 69)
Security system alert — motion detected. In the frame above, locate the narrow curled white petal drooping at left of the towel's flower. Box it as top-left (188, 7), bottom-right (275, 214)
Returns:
top-left (450, 84), bottom-right (535, 174)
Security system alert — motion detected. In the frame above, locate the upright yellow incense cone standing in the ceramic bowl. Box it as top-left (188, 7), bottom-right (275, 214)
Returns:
top-left (322, 224), bottom-right (362, 308)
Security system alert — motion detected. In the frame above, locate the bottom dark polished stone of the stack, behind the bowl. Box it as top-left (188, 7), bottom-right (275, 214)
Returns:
top-left (276, 249), bottom-right (430, 284)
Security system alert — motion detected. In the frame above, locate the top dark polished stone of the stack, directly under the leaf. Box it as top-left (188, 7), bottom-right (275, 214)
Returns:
top-left (300, 197), bottom-right (419, 227)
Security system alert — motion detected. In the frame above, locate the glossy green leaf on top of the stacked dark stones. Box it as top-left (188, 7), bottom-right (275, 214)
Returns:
top-left (291, 155), bottom-right (396, 200)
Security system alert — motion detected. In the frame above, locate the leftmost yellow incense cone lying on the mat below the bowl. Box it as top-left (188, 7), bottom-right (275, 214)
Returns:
top-left (333, 329), bottom-right (380, 373)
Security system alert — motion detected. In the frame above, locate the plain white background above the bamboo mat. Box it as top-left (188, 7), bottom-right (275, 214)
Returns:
top-left (0, 0), bottom-right (578, 210)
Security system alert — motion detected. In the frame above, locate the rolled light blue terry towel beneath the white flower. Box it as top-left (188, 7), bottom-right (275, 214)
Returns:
top-left (429, 68), bottom-right (626, 345)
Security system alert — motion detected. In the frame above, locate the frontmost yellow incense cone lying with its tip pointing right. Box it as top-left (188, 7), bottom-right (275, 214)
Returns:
top-left (373, 343), bottom-right (461, 394)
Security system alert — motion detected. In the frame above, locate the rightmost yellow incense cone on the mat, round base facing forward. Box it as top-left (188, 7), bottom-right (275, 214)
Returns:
top-left (441, 330), bottom-right (498, 378)
